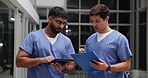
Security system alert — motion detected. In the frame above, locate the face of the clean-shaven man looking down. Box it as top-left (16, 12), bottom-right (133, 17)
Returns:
top-left (90, 15), bottom-right (108, 33)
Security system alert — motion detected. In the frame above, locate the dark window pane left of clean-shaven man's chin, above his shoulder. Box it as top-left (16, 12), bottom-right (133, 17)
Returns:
top-left (81, 26), bottom-right (95, 45)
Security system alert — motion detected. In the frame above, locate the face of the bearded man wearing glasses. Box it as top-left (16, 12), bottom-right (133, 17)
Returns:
top-left (50, 17), bottom-right (66, 34)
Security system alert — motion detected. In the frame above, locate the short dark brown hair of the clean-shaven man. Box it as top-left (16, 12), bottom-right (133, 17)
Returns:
top-left (89, 4), bottom-right (110, 20)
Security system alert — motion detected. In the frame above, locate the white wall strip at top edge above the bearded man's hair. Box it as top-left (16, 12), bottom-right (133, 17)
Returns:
top-left (37, 0), bottom-right (66, 8)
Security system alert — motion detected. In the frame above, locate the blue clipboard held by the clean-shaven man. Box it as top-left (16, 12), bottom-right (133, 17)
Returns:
top-left (71, 51), bottom-right (99, 72)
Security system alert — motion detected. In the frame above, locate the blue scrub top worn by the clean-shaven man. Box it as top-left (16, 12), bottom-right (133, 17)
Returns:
top-left (85, 30), bottom-right (132, 78)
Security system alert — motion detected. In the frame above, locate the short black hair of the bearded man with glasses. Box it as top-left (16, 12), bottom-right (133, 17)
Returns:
top-left (48, 6), bottom-right (67, 19)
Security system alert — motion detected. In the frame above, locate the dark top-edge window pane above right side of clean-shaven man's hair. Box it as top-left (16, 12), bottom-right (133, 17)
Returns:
top-left (100, 0), bottom-right (117, 10)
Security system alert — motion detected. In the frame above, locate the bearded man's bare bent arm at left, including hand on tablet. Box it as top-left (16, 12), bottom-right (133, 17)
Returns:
top-left (16, 49), bottom-right (54, 68)
